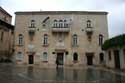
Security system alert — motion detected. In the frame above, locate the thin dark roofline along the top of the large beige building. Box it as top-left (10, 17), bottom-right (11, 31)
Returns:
top-left (15, 11), bottom-right (108, 15)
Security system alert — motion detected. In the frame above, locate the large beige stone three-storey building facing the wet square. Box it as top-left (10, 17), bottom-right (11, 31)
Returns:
top-left (13, 11), bottom-right (108, 66)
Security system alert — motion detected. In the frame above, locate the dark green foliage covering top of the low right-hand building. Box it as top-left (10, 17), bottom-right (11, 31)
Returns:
top-left (102, 34), bottom-right (125, 50)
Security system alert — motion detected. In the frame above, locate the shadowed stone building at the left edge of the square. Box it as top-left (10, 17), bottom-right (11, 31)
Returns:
top-left (0, 7), bottom-right (14, 62)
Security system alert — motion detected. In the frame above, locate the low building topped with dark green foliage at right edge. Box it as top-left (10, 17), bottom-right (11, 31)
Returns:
top-left (103, 34), bottom-right (125, 70)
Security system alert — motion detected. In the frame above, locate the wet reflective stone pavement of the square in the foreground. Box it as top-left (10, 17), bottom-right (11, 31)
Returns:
top-left (0, 64), bottom-right (125, 83)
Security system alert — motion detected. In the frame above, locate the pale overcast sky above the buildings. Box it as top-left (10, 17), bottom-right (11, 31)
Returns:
top-left (0, 0), bottom-right (125, 37)
